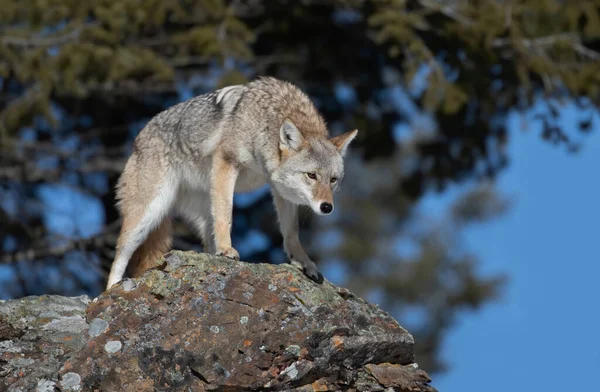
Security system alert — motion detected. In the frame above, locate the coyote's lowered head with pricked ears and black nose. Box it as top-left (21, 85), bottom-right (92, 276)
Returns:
top-left (271, 119), bottom-right (358, 215)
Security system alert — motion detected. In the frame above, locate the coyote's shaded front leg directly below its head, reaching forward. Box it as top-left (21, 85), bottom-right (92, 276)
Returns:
top-left (273, 191), bottom-right (323, 283)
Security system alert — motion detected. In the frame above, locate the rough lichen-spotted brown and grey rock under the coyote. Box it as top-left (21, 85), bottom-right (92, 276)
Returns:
top-left (0, 251), bottom-right (435, 392)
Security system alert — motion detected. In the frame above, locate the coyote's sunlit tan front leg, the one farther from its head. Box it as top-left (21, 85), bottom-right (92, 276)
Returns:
top-left (210, 152), bottom-right (240, 260)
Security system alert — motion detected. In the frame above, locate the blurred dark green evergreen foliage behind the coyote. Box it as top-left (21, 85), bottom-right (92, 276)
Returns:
top-left (0, 0), bottom-right (600, 371)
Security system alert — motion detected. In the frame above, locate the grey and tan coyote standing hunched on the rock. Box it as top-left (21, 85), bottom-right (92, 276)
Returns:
top-left (107, 77), bottom-right (358, 289)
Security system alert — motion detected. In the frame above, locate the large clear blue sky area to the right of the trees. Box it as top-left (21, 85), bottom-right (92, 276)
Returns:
top-left (434, 104), bottom-right (600, 392)
